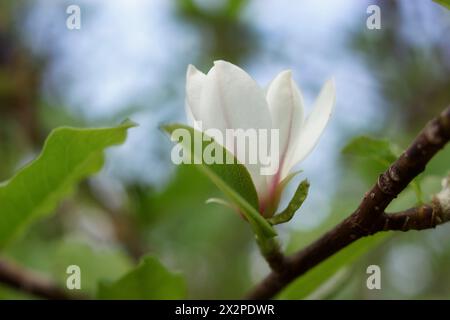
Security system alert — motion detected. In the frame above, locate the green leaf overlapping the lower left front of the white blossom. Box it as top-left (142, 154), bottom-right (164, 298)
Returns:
top-left (162, 124), bottom-right (276, 238)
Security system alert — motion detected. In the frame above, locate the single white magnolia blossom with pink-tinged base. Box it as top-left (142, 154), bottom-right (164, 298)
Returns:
top-left (186, 61), bottom-right (335, 212)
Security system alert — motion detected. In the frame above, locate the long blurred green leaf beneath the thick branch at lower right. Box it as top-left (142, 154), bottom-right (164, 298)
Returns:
top-left (277, 232), bottom-right (391, 299)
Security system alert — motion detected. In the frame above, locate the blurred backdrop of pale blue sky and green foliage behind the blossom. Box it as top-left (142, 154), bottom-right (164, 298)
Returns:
top-left (0, 0), bottom-right (450, 299)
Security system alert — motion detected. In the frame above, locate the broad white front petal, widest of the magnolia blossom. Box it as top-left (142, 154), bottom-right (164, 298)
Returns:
top-left (200, 61), bottom-right (272, 194)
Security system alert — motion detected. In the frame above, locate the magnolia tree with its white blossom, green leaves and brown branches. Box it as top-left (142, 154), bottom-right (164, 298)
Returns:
top-left (0, 55), bottom-right (450, 299)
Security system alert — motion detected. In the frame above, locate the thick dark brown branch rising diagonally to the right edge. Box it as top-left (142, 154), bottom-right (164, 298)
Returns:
top-left (247, 106), bottom-right (450, 299)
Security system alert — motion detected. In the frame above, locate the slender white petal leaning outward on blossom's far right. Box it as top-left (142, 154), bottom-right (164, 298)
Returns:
top-left (290, 80), bottom-right (336, 167)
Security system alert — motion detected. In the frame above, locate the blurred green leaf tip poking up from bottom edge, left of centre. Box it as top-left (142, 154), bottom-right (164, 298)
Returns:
top-left (98, 257), bottom-right (187, 300)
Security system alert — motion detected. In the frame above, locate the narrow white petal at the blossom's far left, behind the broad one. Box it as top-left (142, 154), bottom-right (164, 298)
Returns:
top-left (185, 64), bottom-right (206, 125)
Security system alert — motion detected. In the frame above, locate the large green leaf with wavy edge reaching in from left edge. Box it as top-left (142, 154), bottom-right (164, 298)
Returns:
top-left (0, 121), bottom-right (135, 248)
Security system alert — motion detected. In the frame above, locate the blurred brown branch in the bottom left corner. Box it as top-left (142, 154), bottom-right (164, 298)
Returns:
top-left (0, 259), bottom-right (82, 300)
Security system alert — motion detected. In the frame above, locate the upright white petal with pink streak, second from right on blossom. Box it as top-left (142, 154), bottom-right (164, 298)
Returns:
top-left (266, 70), bottom-right (304, 180)
